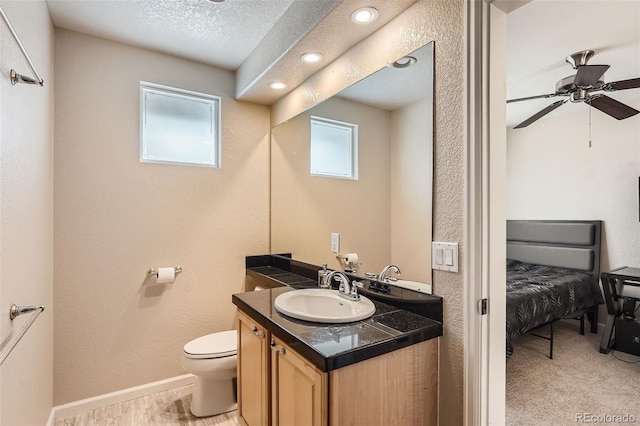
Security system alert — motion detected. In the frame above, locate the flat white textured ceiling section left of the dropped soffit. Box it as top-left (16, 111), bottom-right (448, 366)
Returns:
top-left (47, 0), bottom-right (293, 70)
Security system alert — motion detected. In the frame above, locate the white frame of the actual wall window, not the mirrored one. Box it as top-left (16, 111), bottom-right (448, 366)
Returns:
top-left (140, 81), bottom-right (222, 168)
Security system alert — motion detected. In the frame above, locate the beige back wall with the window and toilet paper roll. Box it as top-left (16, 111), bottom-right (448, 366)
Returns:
top-left (54, 30), bottom-right (269, 404)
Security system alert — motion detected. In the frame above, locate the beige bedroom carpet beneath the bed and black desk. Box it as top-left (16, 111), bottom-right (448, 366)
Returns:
top-left (506, 320), bottom-right (640, 426)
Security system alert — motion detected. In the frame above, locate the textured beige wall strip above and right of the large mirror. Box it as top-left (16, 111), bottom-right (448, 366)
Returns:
top-left (271, 0), bottom-right (467, 426)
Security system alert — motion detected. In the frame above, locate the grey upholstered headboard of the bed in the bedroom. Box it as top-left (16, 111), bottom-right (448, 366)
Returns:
top-left (507, 220), bottom-right (602, 279)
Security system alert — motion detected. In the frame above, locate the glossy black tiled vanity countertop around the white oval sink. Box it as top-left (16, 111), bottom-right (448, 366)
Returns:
top-left (232, 274), bottom-right (442, 372)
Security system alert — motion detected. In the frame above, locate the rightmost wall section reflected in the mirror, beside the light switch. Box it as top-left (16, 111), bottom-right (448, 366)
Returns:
top-left (390, 96), bottom-right (433, 283)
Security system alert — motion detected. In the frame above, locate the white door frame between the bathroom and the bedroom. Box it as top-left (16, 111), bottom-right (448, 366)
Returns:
top-left (464, 0), bottom-right (507, 426)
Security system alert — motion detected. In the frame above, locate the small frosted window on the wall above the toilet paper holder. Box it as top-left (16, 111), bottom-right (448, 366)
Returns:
top-left (140, 82), bottom-right (220, 167)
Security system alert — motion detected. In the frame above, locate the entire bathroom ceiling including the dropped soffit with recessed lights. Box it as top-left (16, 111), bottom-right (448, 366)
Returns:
top-left (47, 0), bottom-right (417, 105)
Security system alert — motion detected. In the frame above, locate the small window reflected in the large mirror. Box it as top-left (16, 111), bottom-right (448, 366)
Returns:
top-left (310, 116), bottom-right (358, 180)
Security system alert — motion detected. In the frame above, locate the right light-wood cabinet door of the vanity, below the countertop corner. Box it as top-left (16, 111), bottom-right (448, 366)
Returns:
top-left (271, 337), bottom-right (328, 426)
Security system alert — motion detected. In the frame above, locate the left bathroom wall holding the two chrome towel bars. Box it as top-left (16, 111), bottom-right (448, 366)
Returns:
top-left (0, 1), bottom-right (54, 425)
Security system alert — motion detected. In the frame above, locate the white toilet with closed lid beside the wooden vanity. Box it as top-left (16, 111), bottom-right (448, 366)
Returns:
top-left (182, 330), bottom-right (238, 417)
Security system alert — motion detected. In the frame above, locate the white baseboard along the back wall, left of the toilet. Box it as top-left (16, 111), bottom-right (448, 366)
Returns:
top-left (52, 374), bottom-right (195, 425)
